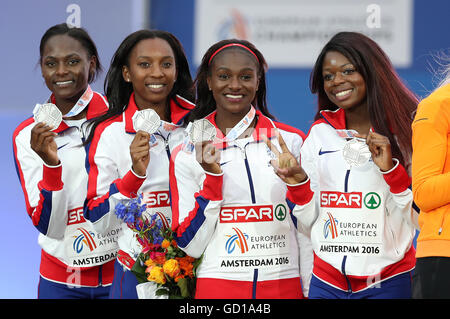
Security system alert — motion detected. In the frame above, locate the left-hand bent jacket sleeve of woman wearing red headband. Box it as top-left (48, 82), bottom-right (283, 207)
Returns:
top-left (170, 149), bottom-right (223, 258)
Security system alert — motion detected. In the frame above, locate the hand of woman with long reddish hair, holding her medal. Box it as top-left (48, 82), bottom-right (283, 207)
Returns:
top-left (355, 131), bottom-right (394, 172)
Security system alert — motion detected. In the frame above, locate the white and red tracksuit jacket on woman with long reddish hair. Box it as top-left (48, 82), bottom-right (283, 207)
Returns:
top-left (288, 109), bottom-right (417, 292)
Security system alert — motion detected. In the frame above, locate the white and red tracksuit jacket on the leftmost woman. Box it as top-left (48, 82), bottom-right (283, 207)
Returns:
top-left (13, 92), bottom-right (117, 287)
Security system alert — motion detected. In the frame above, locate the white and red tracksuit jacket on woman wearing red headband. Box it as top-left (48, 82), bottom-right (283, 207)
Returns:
top-left (170, 111), bottom-right (312, 295)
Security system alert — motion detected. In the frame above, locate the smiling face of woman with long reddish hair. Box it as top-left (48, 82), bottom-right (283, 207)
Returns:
top-left (322, 51), bottom-right (366, 109)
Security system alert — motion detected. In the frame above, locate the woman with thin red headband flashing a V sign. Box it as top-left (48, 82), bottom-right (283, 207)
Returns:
top-left (170, 40), bottom-right (312, 299)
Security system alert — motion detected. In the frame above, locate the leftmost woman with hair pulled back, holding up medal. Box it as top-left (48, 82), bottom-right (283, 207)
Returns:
top-left (13, 23), bottom-right (113, 299)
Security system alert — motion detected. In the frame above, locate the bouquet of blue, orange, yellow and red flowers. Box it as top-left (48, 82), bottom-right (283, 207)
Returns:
top-left (115, 194), bottom-right (201, 299)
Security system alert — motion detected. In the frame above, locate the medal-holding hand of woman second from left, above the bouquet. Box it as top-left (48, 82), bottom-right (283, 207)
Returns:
top-left (130, 131), bottom-right (150, 176)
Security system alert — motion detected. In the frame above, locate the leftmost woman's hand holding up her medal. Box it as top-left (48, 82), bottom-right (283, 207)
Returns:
top-left (30, 123), bottom-right (59, 166)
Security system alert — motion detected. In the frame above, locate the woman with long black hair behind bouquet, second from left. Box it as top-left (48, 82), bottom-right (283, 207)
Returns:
top-left (84, 30), bottom-right (194, 299)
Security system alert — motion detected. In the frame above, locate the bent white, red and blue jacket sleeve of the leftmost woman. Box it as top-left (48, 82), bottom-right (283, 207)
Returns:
top-left (13, 122), bottom-right (68, 239)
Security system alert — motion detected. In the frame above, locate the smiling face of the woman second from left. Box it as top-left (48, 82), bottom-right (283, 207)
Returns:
top-left (122, 38), bottom-right (177, 109)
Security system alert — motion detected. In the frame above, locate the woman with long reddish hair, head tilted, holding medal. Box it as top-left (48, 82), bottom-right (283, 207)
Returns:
top-left (282, 32), bottom-right (417, 298)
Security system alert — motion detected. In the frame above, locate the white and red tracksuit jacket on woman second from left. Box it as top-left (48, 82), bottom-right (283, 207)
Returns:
top-left (84, 93), bottom-right (194, 269)
